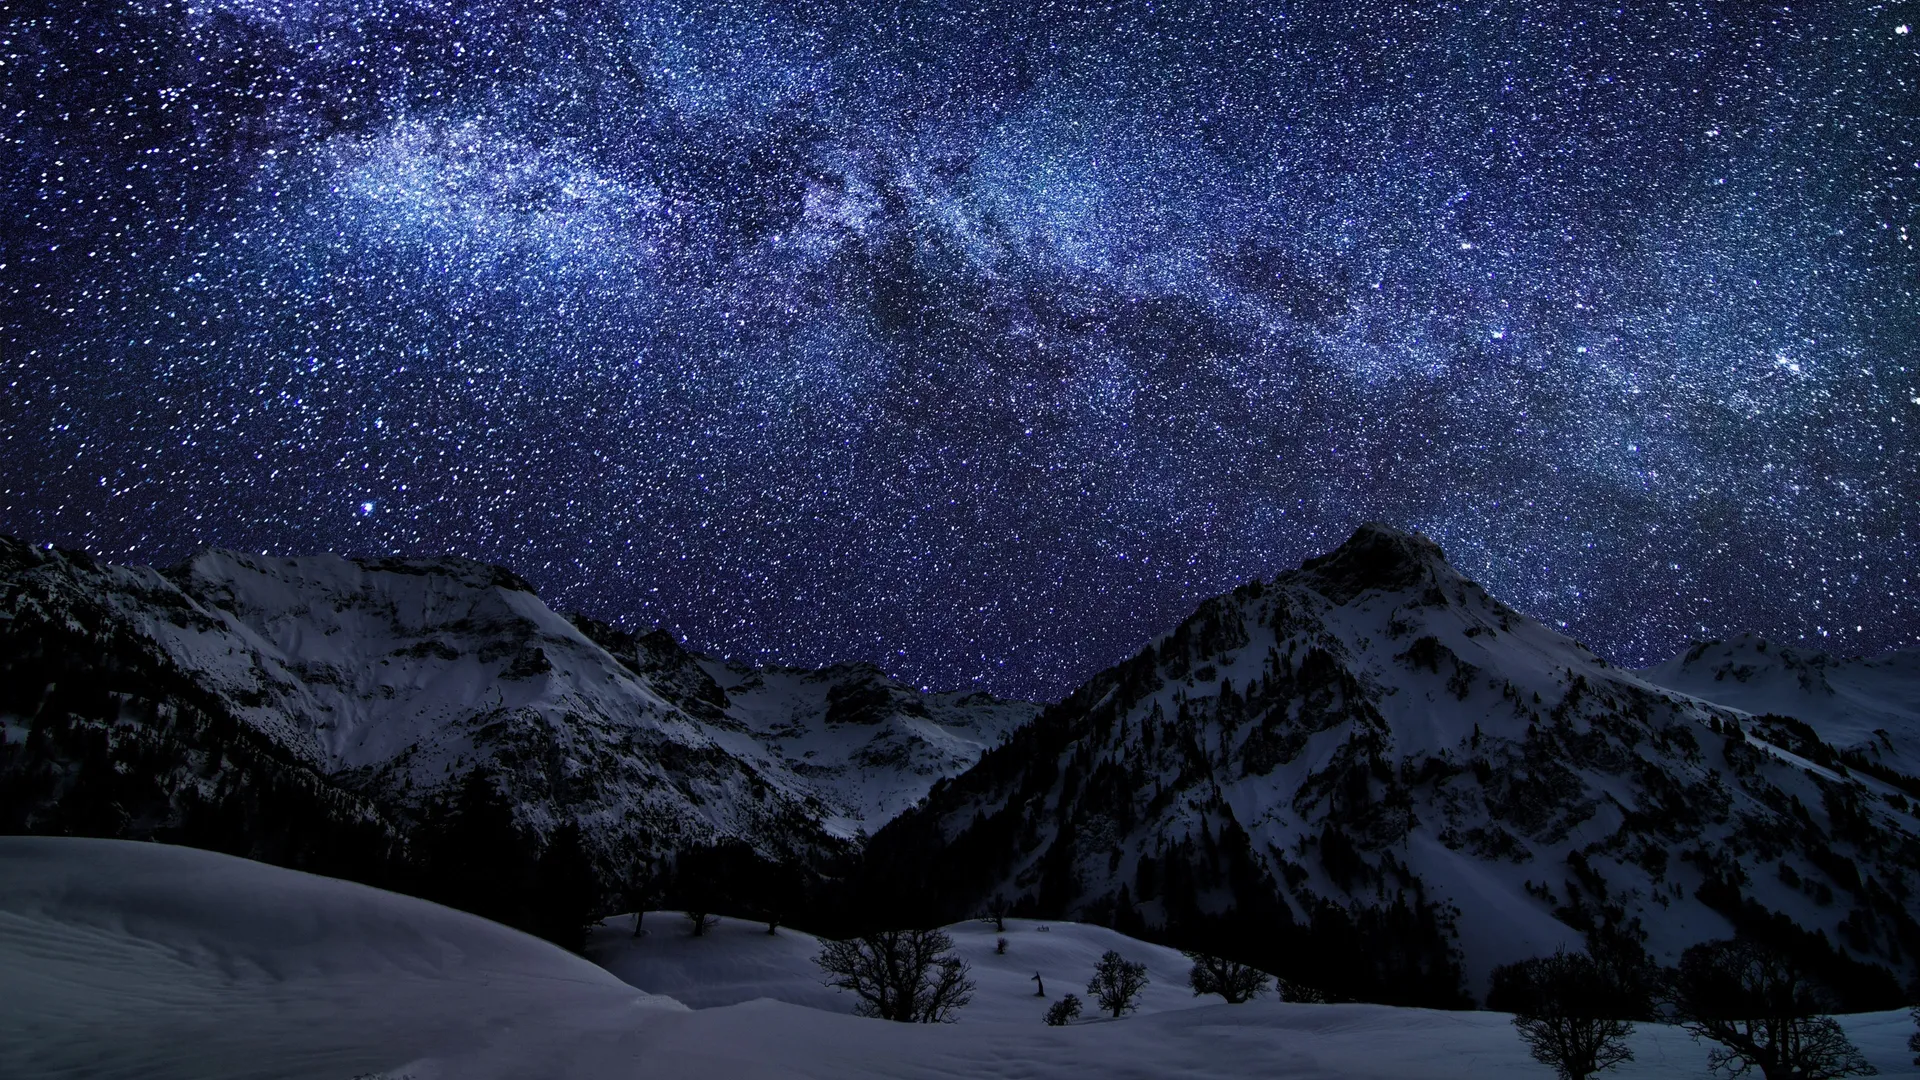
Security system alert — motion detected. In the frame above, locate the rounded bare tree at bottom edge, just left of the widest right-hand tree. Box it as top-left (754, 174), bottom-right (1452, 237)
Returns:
top-left (1494, 953), bottom-right (1634, 1080)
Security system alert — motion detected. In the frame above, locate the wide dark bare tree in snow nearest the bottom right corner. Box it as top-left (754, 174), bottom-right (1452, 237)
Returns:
top-left (1670, 940), bottom-right (1880, 1080)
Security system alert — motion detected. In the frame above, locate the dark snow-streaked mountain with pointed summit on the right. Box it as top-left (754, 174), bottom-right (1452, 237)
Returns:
top-left (868, 525), bottom-right (1920, 1003)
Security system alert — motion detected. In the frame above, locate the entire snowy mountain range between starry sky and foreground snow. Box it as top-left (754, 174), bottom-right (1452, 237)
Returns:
top-left (0, 523), bottom-right (1920, 1005)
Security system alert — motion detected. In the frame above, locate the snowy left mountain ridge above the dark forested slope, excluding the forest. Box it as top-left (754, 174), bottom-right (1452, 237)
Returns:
top-left (0, 540), bottom-right (1029, 861)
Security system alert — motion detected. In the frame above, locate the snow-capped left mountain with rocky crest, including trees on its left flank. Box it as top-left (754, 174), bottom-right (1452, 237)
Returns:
top-left (0, 540), bottom-right (1035, 876)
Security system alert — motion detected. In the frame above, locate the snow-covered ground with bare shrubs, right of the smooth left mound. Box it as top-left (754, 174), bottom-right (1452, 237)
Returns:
top-left (589, 911), bottom-right (1920, 1080)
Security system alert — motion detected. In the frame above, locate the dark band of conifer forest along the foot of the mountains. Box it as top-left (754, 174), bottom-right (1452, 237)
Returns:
top-left (0, 580), bottom-right (1905, 1009)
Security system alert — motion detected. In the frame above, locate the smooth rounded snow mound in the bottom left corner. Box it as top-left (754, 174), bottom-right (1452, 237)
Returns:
top-left (0, 836), bottom-right (680, 1080)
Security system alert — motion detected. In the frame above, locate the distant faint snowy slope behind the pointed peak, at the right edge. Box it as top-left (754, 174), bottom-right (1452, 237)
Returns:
top-left (1640, 634), bottom-right (1920, 776)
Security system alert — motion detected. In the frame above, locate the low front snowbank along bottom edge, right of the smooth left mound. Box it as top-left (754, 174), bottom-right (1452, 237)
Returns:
top-left (622, 1001), bottom-right (1920, 1080)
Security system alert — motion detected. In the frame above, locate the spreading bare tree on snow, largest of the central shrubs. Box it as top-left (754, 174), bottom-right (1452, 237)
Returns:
top-left (814, 930), bottom-right (973, 1024)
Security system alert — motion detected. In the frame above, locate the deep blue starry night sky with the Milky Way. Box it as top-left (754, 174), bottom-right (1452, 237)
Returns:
top-left (0, 0), bottom-right (1920, 698)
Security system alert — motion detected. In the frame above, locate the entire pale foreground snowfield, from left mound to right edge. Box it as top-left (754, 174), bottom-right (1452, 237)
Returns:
top-left (0, 838), bottom-right (1914, 1080)
